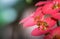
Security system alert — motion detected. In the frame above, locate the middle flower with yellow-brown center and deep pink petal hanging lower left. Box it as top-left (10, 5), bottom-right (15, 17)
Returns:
top-left (32, 17), bottom-right (56, 36)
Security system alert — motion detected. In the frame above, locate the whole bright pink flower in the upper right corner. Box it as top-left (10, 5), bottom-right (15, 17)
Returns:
top-left (36, 0), bottom-right (60, 20)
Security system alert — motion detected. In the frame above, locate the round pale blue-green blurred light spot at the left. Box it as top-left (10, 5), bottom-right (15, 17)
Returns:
top-left (1, 8), bottom-right (18, 24)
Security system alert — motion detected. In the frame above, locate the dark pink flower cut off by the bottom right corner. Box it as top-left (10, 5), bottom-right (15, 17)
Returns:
top-left (44, 27), bottom-right (60, 39)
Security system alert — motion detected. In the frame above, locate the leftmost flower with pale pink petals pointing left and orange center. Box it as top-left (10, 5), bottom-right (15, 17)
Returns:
top-left (20, 8), bottom-right (43, 27)
